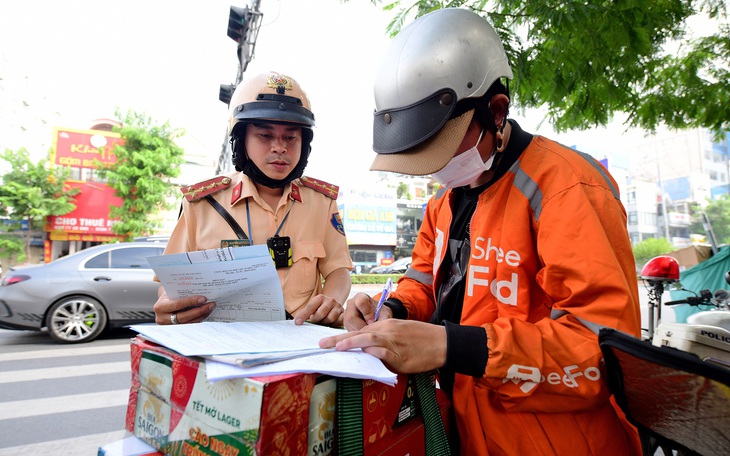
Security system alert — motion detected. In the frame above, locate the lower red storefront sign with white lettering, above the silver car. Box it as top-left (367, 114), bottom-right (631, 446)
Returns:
top-left (45, 181), bottom-right (122, 240)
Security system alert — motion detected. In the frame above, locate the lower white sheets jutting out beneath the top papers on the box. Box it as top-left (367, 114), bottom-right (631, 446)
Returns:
top-left (205, 350), bottom-right (398, 386)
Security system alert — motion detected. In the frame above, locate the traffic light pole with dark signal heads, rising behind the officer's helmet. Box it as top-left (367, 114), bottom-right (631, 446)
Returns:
top-left (215, 0), bottom-right (264, 174)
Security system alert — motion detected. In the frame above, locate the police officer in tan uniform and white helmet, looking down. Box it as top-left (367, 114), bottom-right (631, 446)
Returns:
top-left (154, 72), bottom-right (352, 325)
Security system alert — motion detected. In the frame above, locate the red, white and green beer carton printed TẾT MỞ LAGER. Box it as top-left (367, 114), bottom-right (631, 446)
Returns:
top-left (126, 337), bottom-right (316, 456)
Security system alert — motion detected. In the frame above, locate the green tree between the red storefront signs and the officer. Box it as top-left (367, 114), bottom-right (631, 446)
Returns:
top-left (97, 111), bottom-right (184, 240)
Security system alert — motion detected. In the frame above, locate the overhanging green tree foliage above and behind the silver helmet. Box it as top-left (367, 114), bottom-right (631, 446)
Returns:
top-left (360, 0), bottom-right (730, 135)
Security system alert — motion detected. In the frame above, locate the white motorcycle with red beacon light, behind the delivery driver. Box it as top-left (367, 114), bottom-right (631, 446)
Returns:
top-left (639, 255), bottom-right (730, 368)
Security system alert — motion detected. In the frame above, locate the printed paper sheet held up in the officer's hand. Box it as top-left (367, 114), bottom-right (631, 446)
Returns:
top-left (147, 245), bottom-right (286, 321)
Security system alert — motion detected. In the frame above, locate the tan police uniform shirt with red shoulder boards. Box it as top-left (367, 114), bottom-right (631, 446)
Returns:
top-left (165, 172), bottom-right (353, 315)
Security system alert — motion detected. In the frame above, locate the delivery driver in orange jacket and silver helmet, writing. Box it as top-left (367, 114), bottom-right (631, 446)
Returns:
top-left (320, 9), bottom-right (640, 456)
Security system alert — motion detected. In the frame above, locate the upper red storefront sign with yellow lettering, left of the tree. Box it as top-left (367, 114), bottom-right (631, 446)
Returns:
top-left (51, 128), bottom-right (122, 168)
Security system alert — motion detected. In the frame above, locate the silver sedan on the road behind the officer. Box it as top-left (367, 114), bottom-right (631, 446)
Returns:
top-left (0, 241), bottom-right (166, 343)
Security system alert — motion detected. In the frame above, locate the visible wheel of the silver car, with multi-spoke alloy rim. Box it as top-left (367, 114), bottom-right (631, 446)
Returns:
top-left (46, 296), bottom-right (107, 344)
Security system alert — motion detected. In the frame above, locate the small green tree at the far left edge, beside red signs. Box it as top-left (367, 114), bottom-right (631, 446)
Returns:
top-left (0, 148), bottom-right (80, 261)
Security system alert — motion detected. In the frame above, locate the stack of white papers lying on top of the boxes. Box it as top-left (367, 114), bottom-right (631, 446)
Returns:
top-left (131, 320), bottom-right (396, 385)
